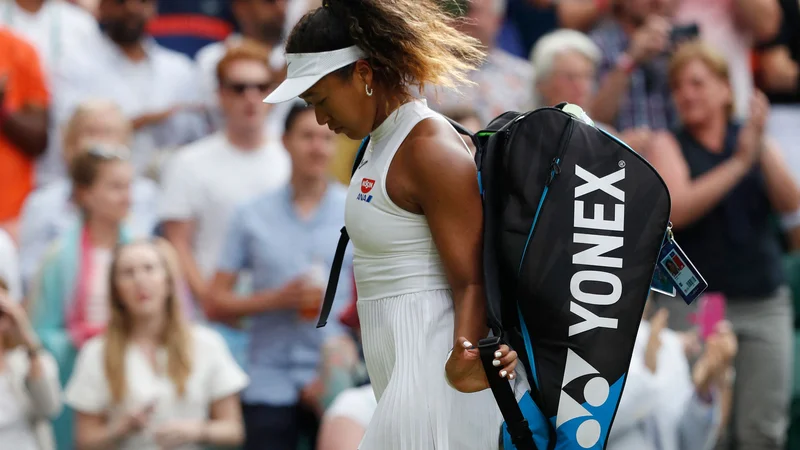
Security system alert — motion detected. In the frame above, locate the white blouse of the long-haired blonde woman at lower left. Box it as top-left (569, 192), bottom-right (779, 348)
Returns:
top-left (64, 325), bottom-right (249, 450)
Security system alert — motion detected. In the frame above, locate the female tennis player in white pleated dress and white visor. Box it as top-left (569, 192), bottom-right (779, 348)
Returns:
top-left (265, 0), bottom-right (524, 450)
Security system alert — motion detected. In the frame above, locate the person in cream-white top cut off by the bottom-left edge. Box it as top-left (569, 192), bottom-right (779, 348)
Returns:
top-left (0, 278), bottom-right (61, 450)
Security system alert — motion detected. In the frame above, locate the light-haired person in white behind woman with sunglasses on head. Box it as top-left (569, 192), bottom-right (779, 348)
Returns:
top-left (19, 99), bottom-right (158, 288)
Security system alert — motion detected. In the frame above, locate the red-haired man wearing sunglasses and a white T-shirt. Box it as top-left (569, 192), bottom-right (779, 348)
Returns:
top-left (159, 41), bottom-right (291, 370)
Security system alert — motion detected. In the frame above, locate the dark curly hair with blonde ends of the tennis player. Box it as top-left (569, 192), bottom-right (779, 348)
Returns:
top-left (286, 0), bottom-right (485, 96)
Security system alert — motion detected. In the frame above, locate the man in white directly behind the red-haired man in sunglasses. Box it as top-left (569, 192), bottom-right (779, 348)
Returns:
top-left (195, 0), bottom-right (312, 135)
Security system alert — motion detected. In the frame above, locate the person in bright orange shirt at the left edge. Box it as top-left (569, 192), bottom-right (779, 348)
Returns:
top-left (0, 29), bottom-right (49, 241)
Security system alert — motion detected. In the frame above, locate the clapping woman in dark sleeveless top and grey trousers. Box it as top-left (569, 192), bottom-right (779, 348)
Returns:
top-left (650, 42), bottom-right (800, 449)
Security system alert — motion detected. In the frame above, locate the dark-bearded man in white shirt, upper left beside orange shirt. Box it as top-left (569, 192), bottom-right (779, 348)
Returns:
top-left (43, 0), bottom-right (208, 185)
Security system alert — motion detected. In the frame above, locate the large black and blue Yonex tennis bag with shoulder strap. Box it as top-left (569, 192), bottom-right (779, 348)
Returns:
top-left (317, 104), bottom-right (670, 450)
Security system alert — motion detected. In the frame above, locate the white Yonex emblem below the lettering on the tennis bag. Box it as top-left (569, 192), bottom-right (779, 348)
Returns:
top-left (556, 349), bottom-right (610, 448)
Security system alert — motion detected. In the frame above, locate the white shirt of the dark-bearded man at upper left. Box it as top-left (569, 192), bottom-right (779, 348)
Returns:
top-left (37, 33), bottom-right (208, 185)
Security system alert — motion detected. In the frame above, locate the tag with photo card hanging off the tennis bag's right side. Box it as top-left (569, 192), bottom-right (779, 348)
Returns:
top-left (650, 224), bottom-right (708, 305)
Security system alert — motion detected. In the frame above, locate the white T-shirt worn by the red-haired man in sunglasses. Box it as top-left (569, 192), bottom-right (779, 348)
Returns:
top-left (159, 132), bottom-right (292, 277)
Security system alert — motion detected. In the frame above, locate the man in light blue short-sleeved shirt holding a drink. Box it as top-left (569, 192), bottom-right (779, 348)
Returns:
top-left (207, 105), bottom-right (352, 450)
